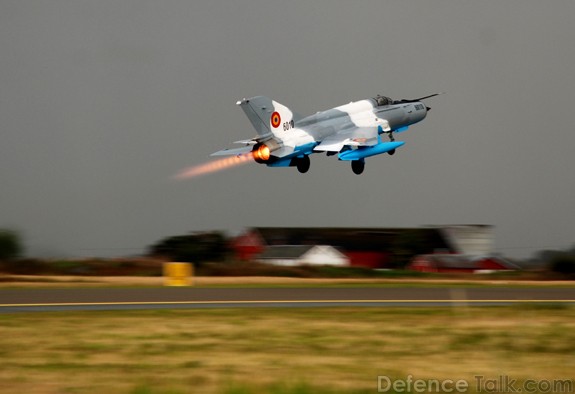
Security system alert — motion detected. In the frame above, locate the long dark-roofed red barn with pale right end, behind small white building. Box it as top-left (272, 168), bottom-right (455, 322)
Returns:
top-left (232, 225), bottom-right (493, 268)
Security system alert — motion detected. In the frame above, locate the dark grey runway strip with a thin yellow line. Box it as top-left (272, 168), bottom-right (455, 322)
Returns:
top-left (0, 286), bottom-right (575, 313)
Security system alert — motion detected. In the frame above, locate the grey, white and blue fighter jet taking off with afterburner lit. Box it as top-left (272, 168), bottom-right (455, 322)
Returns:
top-left (211, 93), bottom-right (441, 174)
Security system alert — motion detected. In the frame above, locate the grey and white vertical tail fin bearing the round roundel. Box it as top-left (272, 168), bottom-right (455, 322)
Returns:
top-left (237, 96), bottom-right (295, 138)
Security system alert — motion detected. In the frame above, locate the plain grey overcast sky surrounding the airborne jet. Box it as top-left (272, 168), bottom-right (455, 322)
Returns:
top-left (0, 0), bottom-right (575, 256)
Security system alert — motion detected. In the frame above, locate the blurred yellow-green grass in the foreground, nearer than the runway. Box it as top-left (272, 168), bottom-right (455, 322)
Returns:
top-left (0, 305), bottom-right (575, 394)
